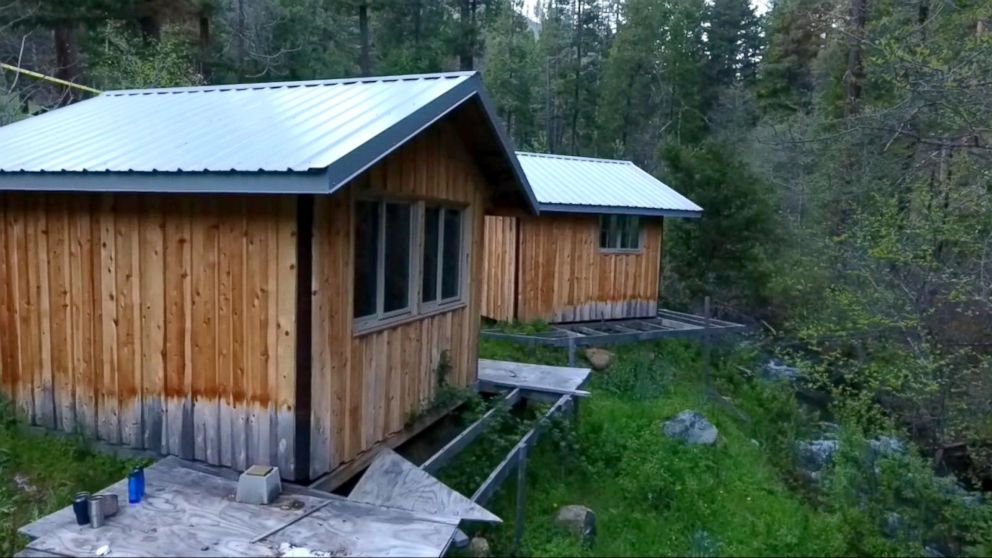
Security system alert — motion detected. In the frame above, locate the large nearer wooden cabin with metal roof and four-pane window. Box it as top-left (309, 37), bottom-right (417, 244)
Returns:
top-left (0, 72), bottom-right (534, 480)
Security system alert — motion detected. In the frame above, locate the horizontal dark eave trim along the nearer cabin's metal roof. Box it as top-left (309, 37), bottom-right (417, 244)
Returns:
top-left (0, 171), bottom-right (327, 194)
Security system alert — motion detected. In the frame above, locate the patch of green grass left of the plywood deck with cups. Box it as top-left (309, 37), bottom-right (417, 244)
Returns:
top-left (0, 401), bottom-right (141, 556)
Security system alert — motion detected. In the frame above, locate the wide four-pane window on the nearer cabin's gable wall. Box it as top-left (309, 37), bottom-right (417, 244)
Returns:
top-left (353, 200), bottom-right (465, 328)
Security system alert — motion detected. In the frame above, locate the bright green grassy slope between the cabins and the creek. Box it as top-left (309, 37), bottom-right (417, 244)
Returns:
top-left (458, 342), bottom-right (846, 556)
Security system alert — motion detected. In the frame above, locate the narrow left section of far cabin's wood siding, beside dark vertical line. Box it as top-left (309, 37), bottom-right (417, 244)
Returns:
top-left (482, 215), bottom-right (517, 322)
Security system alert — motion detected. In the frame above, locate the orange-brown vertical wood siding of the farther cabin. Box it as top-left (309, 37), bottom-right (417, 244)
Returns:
top-left (484, 215), bottom-right (663, 322)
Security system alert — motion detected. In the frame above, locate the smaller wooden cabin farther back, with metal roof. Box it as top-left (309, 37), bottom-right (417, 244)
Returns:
top-left (482, 152), bottom-right (702, 323)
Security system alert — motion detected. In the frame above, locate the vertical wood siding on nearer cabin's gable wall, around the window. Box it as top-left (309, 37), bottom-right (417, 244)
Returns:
top-left (310, 126), bottom-right (486, 476)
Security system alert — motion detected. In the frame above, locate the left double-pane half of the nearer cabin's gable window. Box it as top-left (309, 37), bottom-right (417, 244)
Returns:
top-left (354, 201), bottom-right (413, 320)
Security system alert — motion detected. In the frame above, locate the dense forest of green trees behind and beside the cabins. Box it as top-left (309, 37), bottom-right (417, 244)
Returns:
top-left (0, 0), bottom-right (992, 494)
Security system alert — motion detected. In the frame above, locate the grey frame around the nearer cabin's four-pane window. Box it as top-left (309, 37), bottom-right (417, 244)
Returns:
top-left (349, 198), bottom-right (471, 336)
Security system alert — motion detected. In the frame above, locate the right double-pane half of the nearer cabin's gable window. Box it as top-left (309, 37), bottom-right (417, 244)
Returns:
top-left (421, 206), bottom-right (463, 303)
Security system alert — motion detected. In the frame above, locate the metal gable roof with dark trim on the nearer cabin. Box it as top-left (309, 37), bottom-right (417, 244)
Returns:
top-left (0, 72), bottom-right (534, 209)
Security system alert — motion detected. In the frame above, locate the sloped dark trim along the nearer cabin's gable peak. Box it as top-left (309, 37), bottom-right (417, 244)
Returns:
top-left (327, 73), bottom-right (538, 213)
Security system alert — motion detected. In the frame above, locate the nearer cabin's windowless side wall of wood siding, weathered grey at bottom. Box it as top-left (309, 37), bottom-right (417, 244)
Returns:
top-left (0, 193), bottom-right (296, 472)
